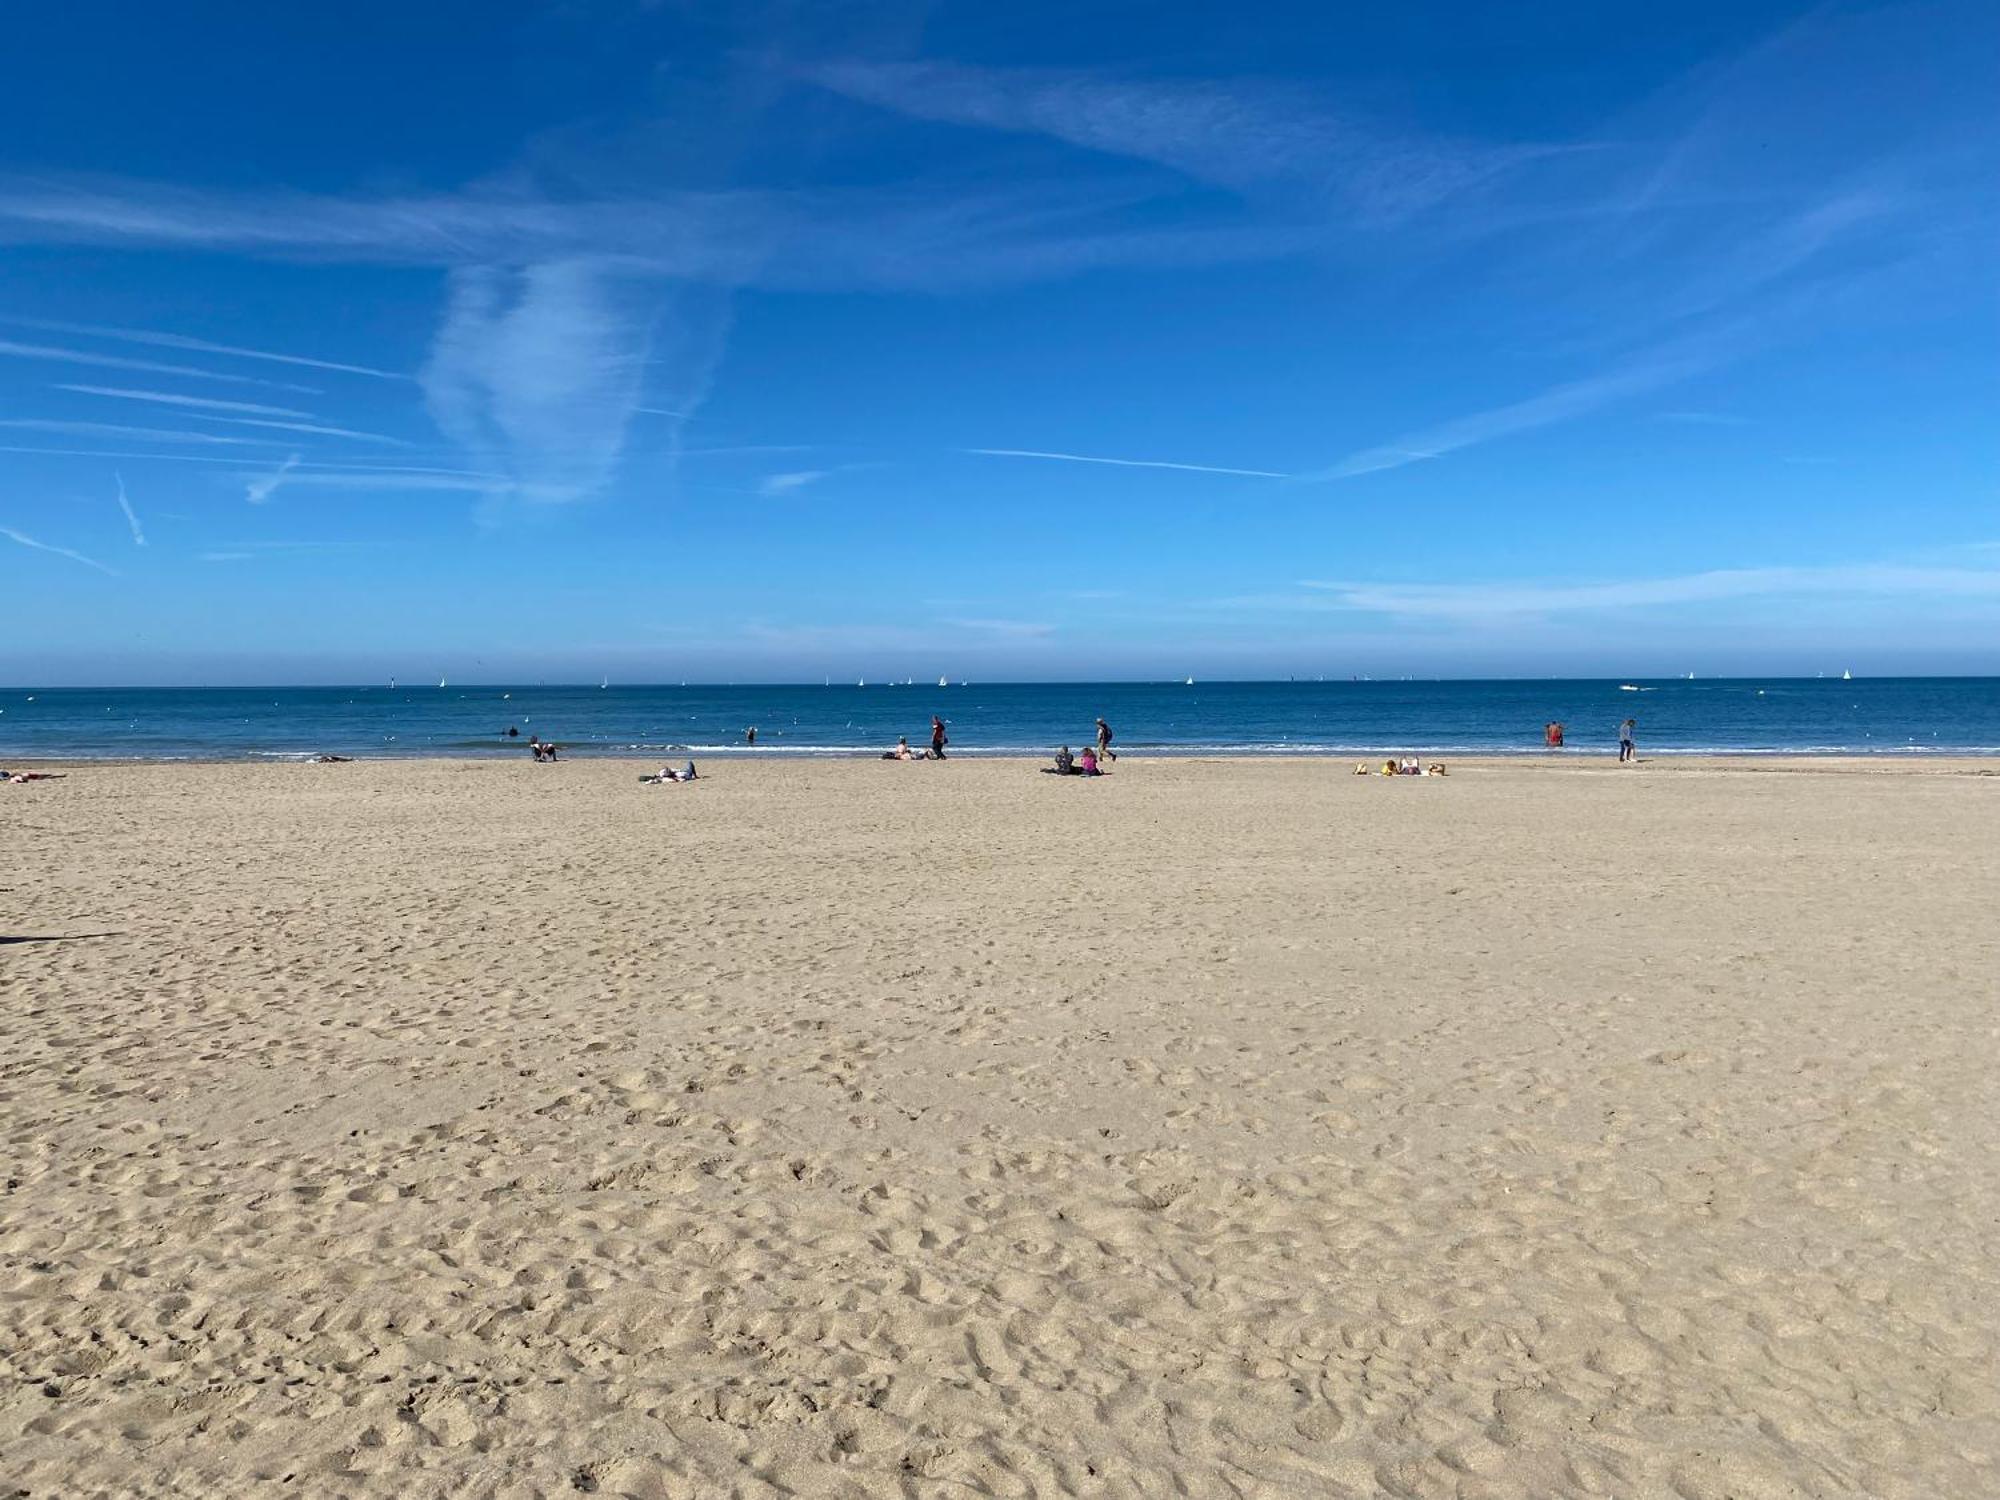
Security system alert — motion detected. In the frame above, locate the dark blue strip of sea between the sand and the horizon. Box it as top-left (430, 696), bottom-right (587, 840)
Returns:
top-left (0, 678), bottom-right (2000, 766)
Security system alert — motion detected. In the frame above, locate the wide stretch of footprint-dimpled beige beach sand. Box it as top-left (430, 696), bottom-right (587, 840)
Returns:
top-left (0, 758), bottom-right (2000, 1500)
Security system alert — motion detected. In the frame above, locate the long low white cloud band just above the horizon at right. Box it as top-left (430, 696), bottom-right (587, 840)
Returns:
top-left (1288, 564), bottom-right (2000, 620)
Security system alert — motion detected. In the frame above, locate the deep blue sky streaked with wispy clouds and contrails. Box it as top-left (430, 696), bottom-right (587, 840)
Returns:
top-left (0, 0), bottom-right (2000, 684)
